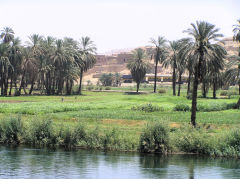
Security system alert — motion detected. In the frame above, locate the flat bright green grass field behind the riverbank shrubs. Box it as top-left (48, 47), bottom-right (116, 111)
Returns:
top-left (0, 86), bottom-right (240, 129)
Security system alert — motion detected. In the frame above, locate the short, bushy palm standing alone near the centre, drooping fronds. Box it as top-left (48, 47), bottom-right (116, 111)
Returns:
top-left (127, 48), bottom-right (150, 93)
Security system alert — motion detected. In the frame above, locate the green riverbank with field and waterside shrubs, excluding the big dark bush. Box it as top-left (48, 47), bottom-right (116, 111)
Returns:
top-left (0, 90), bottom-right (240, 156)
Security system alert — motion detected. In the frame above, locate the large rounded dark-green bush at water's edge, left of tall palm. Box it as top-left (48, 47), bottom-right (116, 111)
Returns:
top-left (140, 122), bottom-right (170, 154)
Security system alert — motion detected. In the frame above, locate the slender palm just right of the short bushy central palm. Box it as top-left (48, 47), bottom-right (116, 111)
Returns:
top-left (150, 36), bottom-right (167, 93)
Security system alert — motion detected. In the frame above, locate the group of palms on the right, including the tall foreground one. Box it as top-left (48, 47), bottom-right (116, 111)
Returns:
top-left (128, 20), bottom-right (240, 126)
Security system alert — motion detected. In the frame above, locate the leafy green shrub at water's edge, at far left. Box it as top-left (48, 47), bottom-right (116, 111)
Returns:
top-left (1, 117), bottom-right (23, 144)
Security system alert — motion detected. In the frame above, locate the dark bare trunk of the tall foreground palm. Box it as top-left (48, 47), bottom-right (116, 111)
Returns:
top-left (191, 52), bottom-right (203, 127)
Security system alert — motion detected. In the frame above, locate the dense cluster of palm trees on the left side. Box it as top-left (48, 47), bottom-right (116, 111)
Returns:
top-left (0, 27), bottom-right (96, 96)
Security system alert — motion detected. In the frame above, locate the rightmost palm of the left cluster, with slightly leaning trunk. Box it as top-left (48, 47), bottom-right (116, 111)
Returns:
top-left (76, 36), bottom-right (97, 94)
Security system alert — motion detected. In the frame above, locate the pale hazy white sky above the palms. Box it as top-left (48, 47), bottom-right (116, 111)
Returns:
top-left (0, 0), bottom-right (240, 53)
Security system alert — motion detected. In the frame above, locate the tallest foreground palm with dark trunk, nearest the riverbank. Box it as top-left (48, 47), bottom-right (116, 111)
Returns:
top-left (184, 21), bottom-right (226, 126)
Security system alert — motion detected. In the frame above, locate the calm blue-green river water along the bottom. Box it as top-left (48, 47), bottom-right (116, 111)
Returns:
top-left (0, 146), bottom-right (240, 179)
